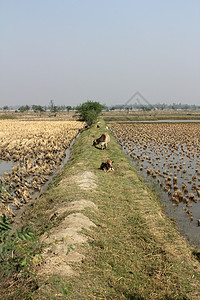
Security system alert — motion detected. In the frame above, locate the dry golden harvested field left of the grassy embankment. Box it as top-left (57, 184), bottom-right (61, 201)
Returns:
top-left (0, 120), bottom-right (84, 216)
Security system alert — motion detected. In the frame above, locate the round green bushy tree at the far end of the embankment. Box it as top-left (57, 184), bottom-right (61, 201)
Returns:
top-left (76, 101), bottom-right (104, 126)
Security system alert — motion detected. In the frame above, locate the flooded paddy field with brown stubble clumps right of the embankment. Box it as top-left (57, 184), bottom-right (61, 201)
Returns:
top-left (109, 123), bottom-right (200, 248)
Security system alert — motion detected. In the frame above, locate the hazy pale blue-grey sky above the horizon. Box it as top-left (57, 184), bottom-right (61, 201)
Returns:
top-left (0, 0), bottom-right (200, 106)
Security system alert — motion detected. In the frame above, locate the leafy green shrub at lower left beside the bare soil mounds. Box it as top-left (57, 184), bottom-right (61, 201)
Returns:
top-left (0, 215), bottom-right (42, 277)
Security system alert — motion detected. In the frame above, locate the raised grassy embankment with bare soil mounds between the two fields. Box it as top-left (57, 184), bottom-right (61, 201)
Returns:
top-left (0, 121), bottom-right (200, 300)
